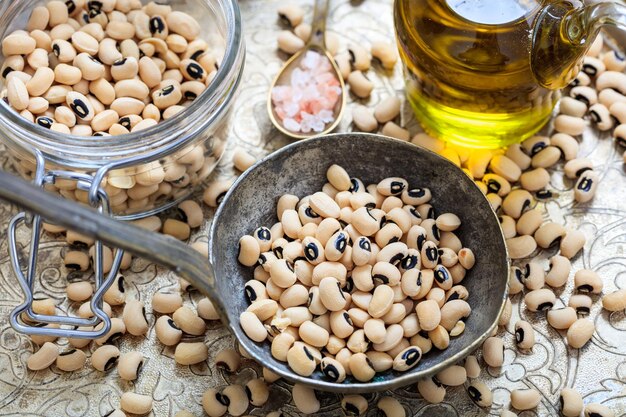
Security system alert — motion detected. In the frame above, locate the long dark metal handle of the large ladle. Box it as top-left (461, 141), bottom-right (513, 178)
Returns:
top-left (0, 171), bottom-right (230, 326)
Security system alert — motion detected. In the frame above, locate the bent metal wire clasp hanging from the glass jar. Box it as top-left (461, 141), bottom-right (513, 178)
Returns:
top-left (8, 147), bottom-right (124, 339)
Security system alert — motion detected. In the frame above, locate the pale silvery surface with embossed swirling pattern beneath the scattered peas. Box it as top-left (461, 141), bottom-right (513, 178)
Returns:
top-left (0, 0), bottom-right (626, 417)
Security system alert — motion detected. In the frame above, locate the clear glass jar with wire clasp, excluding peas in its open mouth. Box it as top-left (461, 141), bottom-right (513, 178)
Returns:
top-left (0, 0), bottom-right (245, 219)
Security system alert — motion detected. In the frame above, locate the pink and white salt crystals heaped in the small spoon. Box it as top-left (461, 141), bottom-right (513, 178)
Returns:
top-left (272, 51), bottom-right (341, 133)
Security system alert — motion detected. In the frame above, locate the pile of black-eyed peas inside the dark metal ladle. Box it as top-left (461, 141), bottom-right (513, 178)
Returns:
top-left (238, 165), bottom-right (475, 382)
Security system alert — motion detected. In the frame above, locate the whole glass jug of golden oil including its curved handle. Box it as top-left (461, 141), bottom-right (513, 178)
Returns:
top-left (394, 0), bottom-right (626, 148)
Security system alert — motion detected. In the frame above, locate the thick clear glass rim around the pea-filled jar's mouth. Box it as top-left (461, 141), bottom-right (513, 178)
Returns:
top-left (0, 0), bottom-right (245, 169)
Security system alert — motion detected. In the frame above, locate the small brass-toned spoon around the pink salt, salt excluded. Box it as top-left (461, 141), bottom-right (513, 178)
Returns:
top-left (267, 0), bottom-right (346, 139)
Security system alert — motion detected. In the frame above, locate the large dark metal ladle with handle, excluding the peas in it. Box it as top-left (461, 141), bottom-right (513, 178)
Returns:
top-left (0, 133), bottom-right (509, 393)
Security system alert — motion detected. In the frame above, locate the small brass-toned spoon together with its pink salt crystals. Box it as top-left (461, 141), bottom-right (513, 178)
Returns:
top-left (267, 0), bottom-right (346, 139)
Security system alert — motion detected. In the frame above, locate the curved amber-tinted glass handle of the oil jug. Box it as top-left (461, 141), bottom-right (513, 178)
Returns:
top-left (531, 1), bottom-right (626, 90)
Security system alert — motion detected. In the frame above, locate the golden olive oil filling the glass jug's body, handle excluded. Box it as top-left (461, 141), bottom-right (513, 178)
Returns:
top-left (394, 0), bottom-right (562, 148)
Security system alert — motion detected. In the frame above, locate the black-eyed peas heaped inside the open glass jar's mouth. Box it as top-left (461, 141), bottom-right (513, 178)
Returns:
top-left (1, 0), bottom-right (221, 136)
